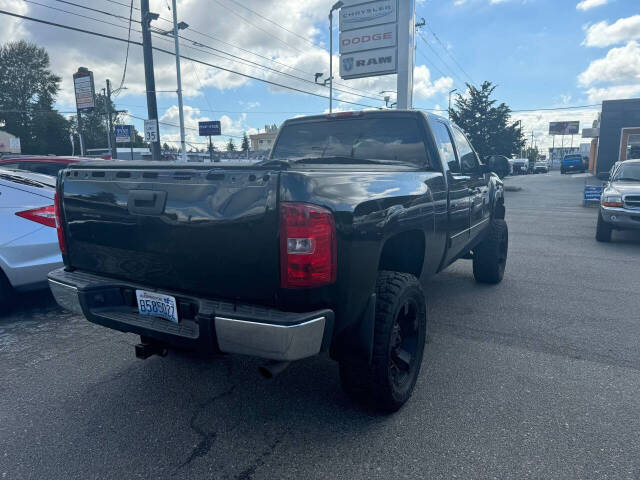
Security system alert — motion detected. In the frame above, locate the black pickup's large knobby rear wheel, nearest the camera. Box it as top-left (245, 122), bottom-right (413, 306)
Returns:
top-left (340, 271), bottom-right (427, 412)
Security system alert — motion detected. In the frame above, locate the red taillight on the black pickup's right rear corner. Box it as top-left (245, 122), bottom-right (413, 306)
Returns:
top-left (280, 202), bottom-right (337, 288)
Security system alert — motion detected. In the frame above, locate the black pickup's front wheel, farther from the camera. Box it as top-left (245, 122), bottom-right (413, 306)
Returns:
top-left (473, 219), bottom-right (509, 284)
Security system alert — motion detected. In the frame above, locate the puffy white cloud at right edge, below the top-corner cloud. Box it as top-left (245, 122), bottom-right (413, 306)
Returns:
top-left (578, 41), bottom-right (640, 87)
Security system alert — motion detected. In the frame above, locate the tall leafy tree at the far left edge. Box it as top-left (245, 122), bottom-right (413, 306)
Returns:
top-left (0, 40), bottom-right (71, 154)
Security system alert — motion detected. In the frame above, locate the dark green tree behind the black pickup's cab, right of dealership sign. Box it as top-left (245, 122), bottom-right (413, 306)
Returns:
top-left (449, 81), bottom-right (525, 158)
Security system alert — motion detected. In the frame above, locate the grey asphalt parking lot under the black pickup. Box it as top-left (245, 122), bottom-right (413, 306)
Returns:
top-left (0, 171), bottom-right (640, 480)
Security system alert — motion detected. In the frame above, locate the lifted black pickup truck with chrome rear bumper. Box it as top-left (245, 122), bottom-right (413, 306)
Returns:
top-left (49, 111), bottom-right (508, 411)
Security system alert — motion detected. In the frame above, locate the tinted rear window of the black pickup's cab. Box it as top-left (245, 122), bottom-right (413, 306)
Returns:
top-left (271, 118), bottom-right (426, 165)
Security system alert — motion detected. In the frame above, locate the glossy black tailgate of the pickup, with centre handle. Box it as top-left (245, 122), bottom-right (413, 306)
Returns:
top-left (59, 163), bottom-right (280, 301)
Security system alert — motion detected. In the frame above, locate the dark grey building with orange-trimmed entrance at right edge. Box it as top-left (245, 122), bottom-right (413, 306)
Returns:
top-left (582, 98), bottom-right (640, 176)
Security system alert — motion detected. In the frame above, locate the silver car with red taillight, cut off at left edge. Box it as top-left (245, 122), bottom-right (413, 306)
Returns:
top-left (0, 169), bottom-right (62, 313)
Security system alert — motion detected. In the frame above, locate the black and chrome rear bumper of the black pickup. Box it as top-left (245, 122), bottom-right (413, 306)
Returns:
top-left (49, 269), bottom-right (334, 361)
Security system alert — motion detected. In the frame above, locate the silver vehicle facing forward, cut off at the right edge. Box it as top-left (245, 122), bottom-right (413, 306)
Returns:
top-left (596, 160), bottom-right (640, 242)
